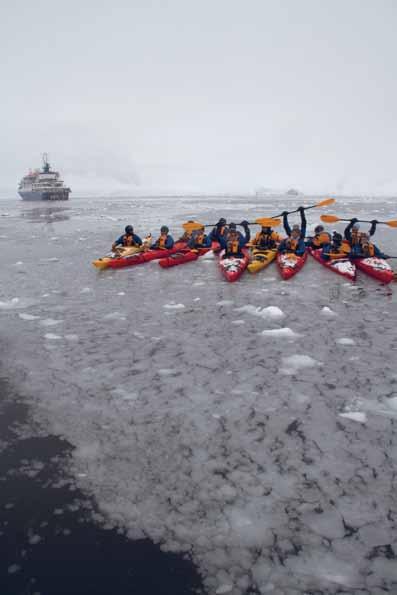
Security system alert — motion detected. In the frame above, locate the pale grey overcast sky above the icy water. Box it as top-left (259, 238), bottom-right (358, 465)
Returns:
top-left (0, 0), bottom-right (397, 195)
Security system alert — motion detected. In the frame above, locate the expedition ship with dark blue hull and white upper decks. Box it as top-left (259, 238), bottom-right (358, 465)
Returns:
top-left (18, 153), bottom-right (71, 200)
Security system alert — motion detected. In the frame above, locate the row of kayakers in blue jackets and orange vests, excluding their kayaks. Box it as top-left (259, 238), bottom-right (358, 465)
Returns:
top-left (112, 212), bottom-right (388, 260)
